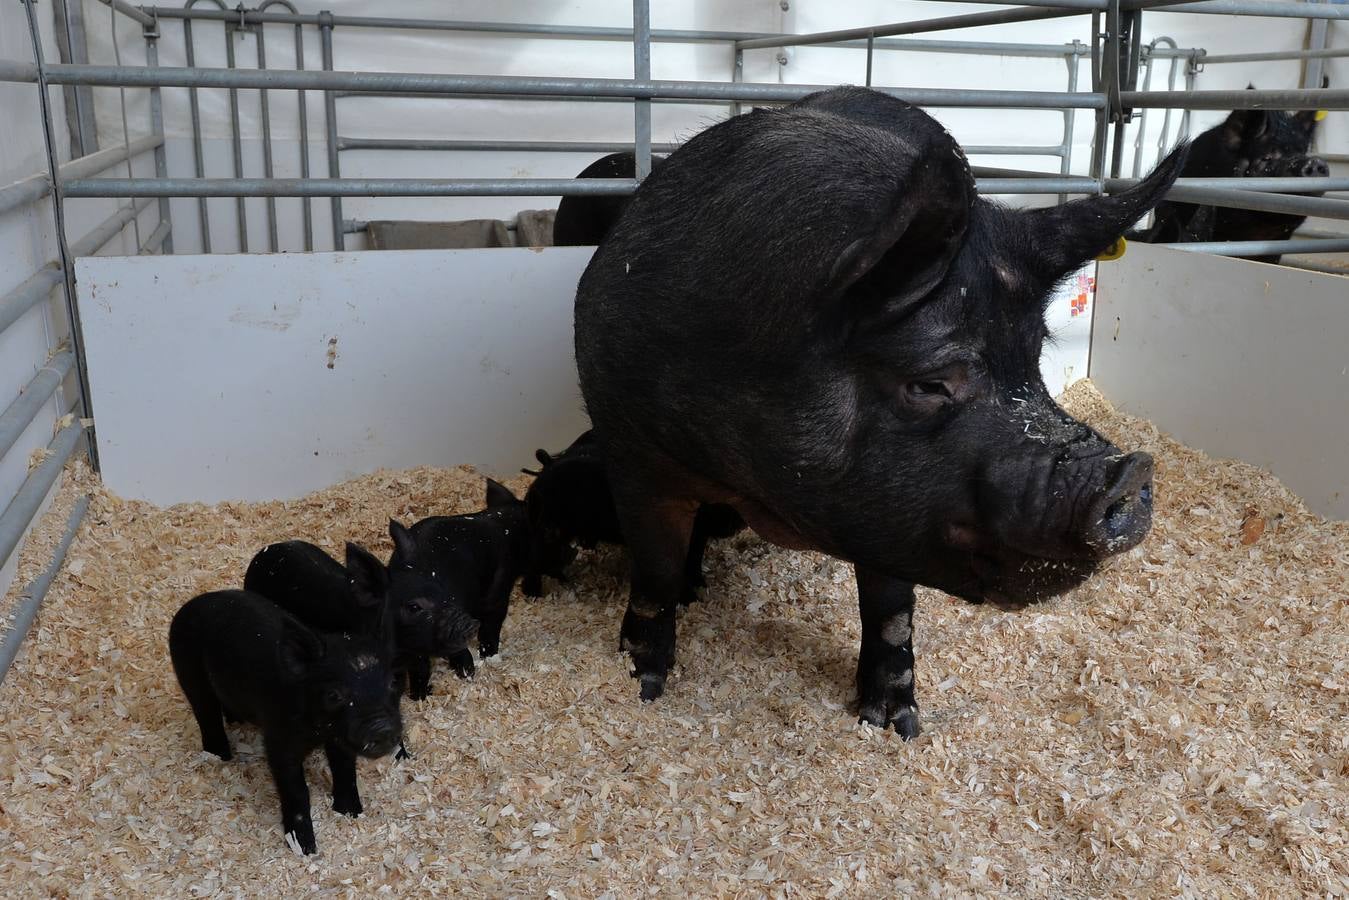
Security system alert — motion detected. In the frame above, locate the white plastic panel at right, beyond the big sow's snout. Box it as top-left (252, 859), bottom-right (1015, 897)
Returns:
top-left (1091, 244), bottom-right (1349, 518)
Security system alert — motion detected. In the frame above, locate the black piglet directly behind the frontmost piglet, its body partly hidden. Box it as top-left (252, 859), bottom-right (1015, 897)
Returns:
top-left (244, 539), bottom-right (478, 700)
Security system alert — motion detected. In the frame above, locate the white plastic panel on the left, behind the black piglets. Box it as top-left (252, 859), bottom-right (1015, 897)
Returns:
top-left (77, 247), bottom-right (591, 503)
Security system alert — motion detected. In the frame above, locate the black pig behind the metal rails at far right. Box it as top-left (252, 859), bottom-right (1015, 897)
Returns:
top-left (1129, 81), bottom-right (1330, 263)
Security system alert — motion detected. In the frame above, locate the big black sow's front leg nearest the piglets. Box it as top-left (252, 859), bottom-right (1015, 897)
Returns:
top-left (615, 486), bottom-right (697, 702)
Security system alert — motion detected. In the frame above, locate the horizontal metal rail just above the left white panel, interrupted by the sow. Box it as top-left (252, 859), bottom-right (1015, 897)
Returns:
top-left (66, 175), bottom-right (1101, 197)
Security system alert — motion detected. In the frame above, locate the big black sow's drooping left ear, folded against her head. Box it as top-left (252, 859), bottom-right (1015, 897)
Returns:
top-left (826, 154), bottom-right (975, 306)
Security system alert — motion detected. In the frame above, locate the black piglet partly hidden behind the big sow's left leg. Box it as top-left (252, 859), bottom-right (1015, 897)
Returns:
top-left (521, 432), bottom-right (745, 604)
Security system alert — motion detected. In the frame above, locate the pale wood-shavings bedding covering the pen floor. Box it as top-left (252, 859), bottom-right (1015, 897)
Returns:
top-left (0, 386), bottom-right (1349, 897)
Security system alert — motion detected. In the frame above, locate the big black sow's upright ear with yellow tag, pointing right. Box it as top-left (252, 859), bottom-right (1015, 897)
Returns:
top-left (1020, 143), bottom-right (1190, 283)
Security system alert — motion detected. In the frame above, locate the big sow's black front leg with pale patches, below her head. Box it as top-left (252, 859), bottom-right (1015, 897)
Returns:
top-left (854, 565), bottom-right (921, 741)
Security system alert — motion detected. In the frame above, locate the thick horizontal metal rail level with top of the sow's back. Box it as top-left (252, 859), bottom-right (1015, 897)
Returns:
top-left (0, 62), bottom-right (1111, 109)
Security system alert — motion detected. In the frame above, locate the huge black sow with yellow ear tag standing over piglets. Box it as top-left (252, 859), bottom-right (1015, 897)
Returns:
top-left (575, 88), bottom-right (1184, 737)
